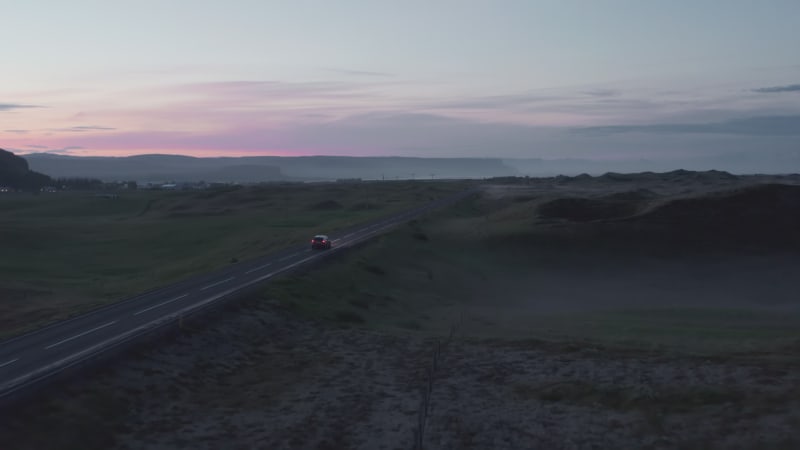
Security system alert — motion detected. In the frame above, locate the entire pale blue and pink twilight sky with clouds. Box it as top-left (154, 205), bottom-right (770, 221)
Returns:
top-left (0, 0), bottom-right (800, 168)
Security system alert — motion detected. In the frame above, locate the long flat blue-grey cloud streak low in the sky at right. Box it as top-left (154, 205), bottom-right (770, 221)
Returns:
top-left (573, 115), bottom-right (800, 136)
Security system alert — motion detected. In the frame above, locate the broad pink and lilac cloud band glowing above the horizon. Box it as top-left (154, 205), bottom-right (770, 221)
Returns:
top-left (0, 81), bottom-right (792, 160)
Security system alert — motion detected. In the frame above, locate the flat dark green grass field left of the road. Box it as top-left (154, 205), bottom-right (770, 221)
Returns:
top-left (0, 181), bottom-right (472, 336)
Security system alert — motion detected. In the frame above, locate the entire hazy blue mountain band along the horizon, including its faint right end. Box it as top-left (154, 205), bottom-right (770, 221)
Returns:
top-left (20, 153), bottom-right (800, 183)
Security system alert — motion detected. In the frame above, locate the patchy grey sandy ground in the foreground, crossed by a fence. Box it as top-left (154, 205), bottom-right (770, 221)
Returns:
top-left (0, 298), bottom-right (800, 449)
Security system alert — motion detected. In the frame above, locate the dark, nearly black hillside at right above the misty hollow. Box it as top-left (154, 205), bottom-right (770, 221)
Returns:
top-left (538, 183), bottom-right (800, 254)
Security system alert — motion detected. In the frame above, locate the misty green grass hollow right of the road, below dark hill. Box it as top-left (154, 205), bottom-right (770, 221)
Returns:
top-left (265, 192), bottom-right (800, 354)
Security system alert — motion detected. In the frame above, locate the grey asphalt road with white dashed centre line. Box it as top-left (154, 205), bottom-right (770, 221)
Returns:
top-left (0, 190), bottom-right (474, 401)
